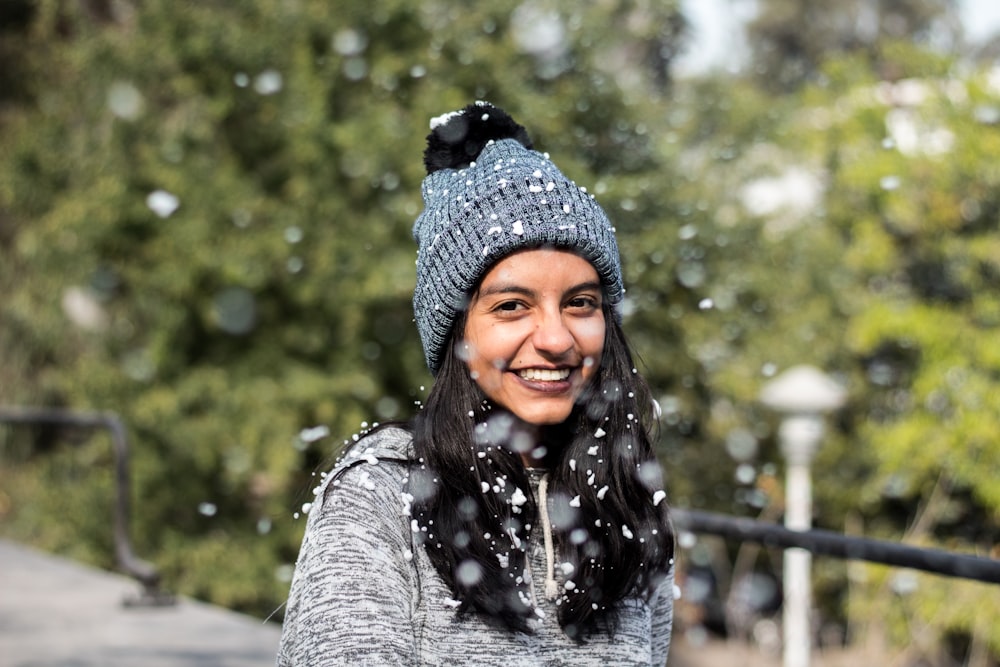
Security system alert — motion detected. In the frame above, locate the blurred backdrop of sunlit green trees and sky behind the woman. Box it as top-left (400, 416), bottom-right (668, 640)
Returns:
top-left (0, 0), bottom-right (1000, 666)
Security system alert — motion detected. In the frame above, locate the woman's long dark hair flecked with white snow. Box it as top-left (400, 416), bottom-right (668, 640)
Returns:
top-left (408, 306), bottom-right (674, 639)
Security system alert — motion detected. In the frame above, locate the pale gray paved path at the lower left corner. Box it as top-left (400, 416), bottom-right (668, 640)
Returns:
top-left (0, 539), bottom-right (280, 667)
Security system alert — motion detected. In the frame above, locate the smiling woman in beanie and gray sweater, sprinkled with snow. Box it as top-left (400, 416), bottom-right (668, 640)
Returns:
top-left (278, 102), bottom-right (673, 666)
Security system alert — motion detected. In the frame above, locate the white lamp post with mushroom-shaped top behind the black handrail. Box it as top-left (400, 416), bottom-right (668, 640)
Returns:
top-left (760, 366), bottom-right (847, 667)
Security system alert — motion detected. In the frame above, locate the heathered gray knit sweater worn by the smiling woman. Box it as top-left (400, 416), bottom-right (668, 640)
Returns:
top-left (277, 428), bottom-right (673, 667)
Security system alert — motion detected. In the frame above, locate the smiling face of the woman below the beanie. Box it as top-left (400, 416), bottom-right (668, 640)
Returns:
top-left (459, 248), bottom-right (605, 426)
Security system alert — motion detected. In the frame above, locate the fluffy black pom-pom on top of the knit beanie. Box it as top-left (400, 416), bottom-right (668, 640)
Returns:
top-left (424, 102), bottom-right (532, 174)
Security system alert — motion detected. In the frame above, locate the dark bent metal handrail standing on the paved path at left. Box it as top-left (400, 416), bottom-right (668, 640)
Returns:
top-left (0, 406), bottom-right (173, 605)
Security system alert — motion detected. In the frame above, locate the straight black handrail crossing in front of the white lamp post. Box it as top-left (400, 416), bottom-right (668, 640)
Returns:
top-left (671, 509), bottom-right (1000, 584)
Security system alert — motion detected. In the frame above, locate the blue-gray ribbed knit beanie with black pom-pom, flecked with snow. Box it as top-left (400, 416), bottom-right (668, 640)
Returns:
top-left (413, 102), bottom-right (624, 375)
